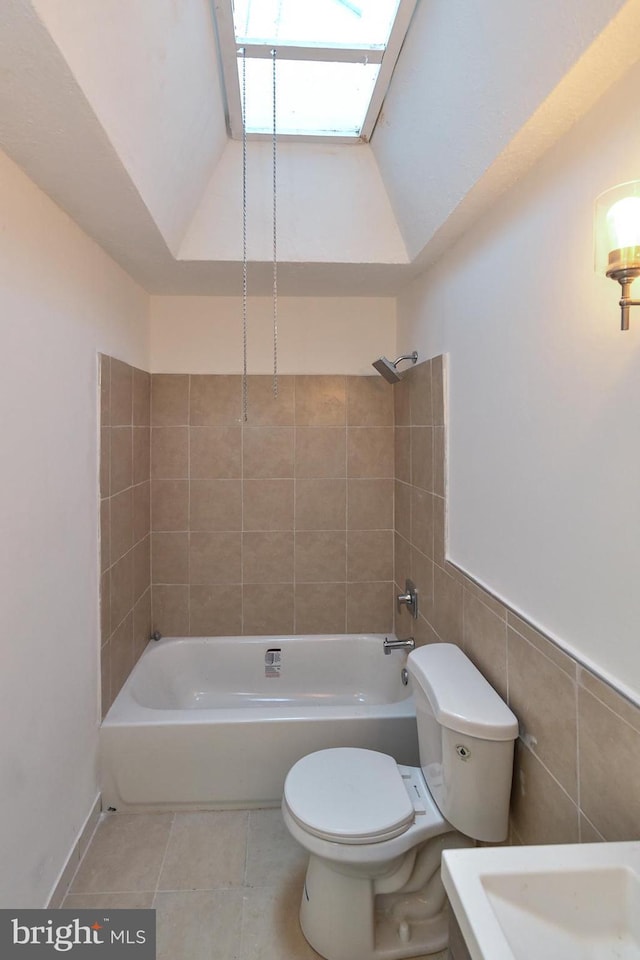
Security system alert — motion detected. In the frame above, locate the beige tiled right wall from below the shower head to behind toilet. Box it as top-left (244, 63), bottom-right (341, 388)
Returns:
top-left (394, 357), bottom-right (640, 843)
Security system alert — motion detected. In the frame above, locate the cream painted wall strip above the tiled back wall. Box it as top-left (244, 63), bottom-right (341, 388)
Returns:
top-left (150, 296), bottom-right (395, 375)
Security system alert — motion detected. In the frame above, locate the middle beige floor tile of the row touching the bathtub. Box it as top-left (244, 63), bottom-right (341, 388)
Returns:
top-left (158, 810), bottom-right (248, 890)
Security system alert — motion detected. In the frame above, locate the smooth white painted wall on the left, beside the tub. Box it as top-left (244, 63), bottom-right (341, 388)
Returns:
top-left (0, 146), bottom-right (148, 907)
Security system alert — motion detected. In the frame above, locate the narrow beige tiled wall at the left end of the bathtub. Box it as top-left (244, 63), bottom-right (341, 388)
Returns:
top-left (99, 356), bottom-right (151, 715)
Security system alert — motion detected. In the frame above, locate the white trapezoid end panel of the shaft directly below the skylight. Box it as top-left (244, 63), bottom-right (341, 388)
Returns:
top-left (179, 140), bottom-right (407, 263)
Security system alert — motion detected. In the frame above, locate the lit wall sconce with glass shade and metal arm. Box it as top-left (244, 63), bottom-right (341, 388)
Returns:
top-left (596, 180), bottom-right (640, 330)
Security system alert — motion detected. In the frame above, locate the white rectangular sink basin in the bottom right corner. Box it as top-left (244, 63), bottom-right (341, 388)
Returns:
top-left (442, 841), bottom-right (640, 960)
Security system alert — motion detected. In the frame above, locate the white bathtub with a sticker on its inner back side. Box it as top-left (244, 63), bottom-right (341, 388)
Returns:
top-left (100, 634), bottom-right (418, 811)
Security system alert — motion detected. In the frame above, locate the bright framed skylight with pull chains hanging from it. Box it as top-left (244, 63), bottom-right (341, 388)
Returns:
top-left (214, 0), bottom-right (417, 141)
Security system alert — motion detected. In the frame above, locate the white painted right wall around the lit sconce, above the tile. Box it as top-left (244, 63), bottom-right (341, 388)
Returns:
top-left (398, 65), bottom-right (640, 701)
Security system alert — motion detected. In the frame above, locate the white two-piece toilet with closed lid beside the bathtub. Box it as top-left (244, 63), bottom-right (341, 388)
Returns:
top-left (282, 643), bottom-right (518, 960)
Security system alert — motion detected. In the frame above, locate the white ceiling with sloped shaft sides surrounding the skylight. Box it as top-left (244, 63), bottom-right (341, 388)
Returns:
top-left (0, 0), bottom-right (640, 296)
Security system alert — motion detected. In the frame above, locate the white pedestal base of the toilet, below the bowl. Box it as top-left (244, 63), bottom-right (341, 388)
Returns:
top-left (300, 848), bottom-right (460, 960)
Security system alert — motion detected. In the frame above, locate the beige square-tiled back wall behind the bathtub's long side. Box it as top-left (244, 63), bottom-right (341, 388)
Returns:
top-left (151, 374), bottom-right (394, 636)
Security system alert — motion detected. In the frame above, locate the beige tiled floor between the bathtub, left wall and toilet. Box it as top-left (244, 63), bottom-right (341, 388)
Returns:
top-left (62, 810), bottom-right (447, 960)
